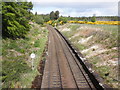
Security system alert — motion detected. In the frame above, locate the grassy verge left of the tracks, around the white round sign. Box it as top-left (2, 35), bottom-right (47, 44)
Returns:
top-left (1, 24), bottom-right (48, 88)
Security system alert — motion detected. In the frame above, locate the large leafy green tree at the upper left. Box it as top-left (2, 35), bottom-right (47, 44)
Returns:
top-left (2, 2), bottom-right (33, 39)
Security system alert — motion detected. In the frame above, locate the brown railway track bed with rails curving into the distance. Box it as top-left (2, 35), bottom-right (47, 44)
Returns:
top-left (41, 25), bottom-right (110, 90)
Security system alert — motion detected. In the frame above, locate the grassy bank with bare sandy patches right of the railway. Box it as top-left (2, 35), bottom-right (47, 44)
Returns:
top-left (57, 24), bottom-right (119, 88)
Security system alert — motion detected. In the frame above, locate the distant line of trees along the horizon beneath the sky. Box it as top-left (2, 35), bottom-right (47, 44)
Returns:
top-left (35, 11), bottom-right (118, 24)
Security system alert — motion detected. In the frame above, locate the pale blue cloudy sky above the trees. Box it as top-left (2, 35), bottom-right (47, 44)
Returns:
top-left (27, 0), bottom-right (119, 17)
